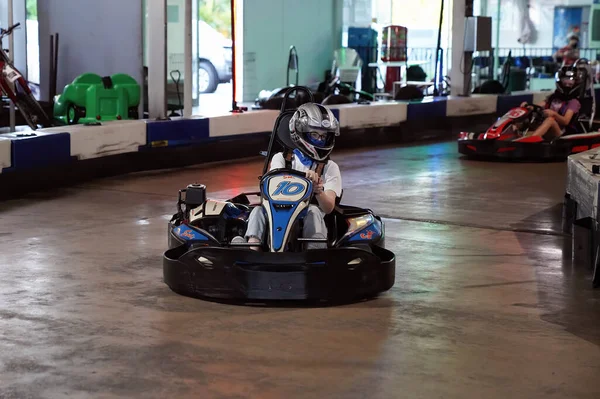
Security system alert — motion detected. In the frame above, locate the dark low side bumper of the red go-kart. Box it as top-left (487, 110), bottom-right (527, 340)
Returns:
top-left (458, 137), bottom-right (600, 161)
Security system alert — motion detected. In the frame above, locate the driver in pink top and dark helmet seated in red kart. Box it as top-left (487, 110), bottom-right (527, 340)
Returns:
top-left (521, 60), bottom-right (588, 138)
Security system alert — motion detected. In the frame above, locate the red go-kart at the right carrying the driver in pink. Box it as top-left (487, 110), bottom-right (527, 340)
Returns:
top-left (458, 99), bottom-right (600, 160)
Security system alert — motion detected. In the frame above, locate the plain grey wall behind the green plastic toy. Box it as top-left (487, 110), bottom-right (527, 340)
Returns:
top-left (38, 0), bottom-right (143, 100)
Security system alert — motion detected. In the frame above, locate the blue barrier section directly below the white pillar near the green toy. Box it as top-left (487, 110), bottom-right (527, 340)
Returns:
top-left (146, 118), bottom-right (210, 147)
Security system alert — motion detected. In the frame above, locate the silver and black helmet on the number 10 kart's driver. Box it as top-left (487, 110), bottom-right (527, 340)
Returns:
top-left (290, 103), bottom-right (340, 162)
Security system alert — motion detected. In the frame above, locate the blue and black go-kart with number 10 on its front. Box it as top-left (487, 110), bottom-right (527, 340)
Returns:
top-left (163, 86), bottom-right (396, 302)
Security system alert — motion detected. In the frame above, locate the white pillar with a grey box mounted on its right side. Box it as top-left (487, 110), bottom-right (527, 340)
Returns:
top-left (450, 0), bottom-right (473, 96)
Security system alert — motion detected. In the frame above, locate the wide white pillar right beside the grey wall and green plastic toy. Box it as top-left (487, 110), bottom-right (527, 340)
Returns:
top-left (147, 0), bottom-right (167, 119)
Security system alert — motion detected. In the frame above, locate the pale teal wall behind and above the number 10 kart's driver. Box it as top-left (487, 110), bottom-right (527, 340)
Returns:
top-left (242, 0), bottom-right (343, 101)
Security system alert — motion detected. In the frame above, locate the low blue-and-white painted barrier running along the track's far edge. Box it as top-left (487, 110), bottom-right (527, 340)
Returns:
top-left (0, 92), bottom-right (550, 173)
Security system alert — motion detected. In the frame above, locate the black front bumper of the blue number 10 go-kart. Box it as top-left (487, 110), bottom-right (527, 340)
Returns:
top-left (163, 244), bottom-right (396, 301)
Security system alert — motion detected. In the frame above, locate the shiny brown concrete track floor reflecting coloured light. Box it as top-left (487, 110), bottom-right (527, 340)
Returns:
top-left (0, 143), bottom-right (600, 399)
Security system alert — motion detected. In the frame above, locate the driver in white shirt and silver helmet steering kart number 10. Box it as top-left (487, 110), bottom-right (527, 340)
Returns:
top-left (232, 103), bottom-right (342, 250)
